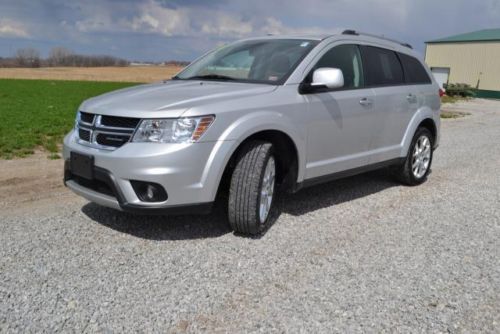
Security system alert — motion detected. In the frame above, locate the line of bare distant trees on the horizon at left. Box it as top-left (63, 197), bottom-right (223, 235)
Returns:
top-left (0, 47), bottom-right (129, 67)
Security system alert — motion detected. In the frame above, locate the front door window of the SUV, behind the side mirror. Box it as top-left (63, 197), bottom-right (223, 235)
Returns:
top-left (314, 45), bottom-right (364, 88)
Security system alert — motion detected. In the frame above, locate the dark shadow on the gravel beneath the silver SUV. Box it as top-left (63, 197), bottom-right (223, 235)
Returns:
top-left (82, 170), bottom-right (399, 241)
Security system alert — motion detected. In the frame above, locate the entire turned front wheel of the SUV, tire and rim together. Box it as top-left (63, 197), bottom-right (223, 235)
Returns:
top-left (228, 141), bottom-right (277, 234)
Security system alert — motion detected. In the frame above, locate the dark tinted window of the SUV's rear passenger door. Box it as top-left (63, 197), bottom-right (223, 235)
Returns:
top-left (361, 46), bottom-right (404, 86)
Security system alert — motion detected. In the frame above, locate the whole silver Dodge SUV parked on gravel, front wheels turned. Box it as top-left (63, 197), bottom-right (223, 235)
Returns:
top-left (64, 30), bottom-right (440, 234)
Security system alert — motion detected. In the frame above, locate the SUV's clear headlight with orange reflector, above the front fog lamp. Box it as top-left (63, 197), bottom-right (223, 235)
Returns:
top-left (132, 116), bottom-right (215, 143)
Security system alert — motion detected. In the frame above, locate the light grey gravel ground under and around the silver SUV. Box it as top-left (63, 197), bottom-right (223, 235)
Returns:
top-left (0, 100), bottom-right (500, 333)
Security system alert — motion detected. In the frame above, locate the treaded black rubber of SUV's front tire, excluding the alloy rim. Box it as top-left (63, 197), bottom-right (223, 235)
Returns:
top-left (228, 140), bottom-right (277, 235)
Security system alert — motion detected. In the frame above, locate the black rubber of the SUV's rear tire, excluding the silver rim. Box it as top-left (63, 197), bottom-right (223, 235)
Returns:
top-left (393, 127), bottom-right (434, 186)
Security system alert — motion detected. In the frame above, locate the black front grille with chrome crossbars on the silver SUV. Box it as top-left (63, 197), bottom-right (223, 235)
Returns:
top-left (78, 112), bottom-right (141, 150)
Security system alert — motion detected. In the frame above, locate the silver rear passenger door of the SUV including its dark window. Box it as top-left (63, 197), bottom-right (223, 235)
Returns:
top-left (361, 45), bottom-right (418, 164)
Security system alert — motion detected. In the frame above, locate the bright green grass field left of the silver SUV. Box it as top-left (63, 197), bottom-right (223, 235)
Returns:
top-left (0, 79), bottom-right (137, 159)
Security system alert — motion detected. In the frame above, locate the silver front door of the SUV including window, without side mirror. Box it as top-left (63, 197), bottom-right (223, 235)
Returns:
top-left (304, 44), bottom-right (373, 179)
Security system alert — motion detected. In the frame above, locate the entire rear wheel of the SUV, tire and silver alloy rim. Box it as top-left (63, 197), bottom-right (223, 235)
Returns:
top-left (395, 128), bottom-right (434, 186)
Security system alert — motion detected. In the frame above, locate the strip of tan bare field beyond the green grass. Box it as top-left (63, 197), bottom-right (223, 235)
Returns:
top-left (0, 66), bottom-right (182, 82)
